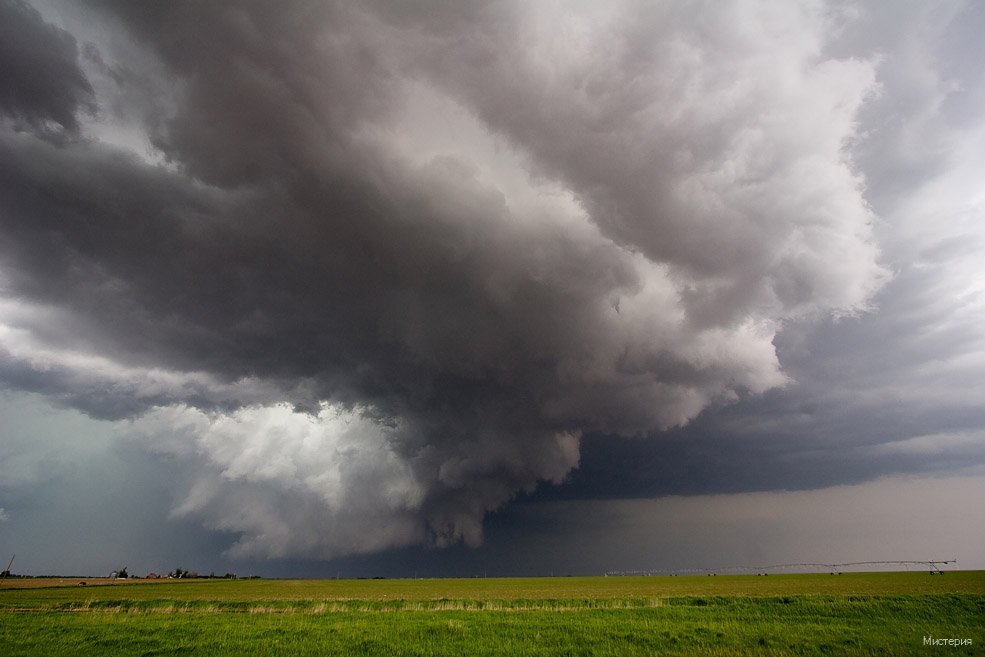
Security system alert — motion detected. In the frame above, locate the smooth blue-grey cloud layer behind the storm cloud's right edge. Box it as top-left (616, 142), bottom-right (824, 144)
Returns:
top-left (545, 3), bottom-right (985, 497)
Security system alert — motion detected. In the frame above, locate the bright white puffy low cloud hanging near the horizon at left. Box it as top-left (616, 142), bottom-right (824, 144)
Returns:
top-left (121, 404), bottom-right (425, 557)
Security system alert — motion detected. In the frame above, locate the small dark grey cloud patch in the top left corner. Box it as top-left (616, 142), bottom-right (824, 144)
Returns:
top-left (0, 0), bottom-right (93, 131)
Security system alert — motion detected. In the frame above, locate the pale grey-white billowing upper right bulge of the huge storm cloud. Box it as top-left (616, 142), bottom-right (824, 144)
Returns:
top-left (396, 2), bottom-right (885, 325)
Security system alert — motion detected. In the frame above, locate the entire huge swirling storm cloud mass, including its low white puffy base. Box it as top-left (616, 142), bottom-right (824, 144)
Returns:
top-left (0, 0), bottom-right (887, 558)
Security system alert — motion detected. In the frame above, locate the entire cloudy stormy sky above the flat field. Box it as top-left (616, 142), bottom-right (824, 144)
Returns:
top-left (0, 0), bottom-right (985, 576)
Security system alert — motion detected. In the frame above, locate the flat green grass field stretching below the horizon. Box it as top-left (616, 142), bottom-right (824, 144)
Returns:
top-left (0, 571), bottom-right (985, 656)
